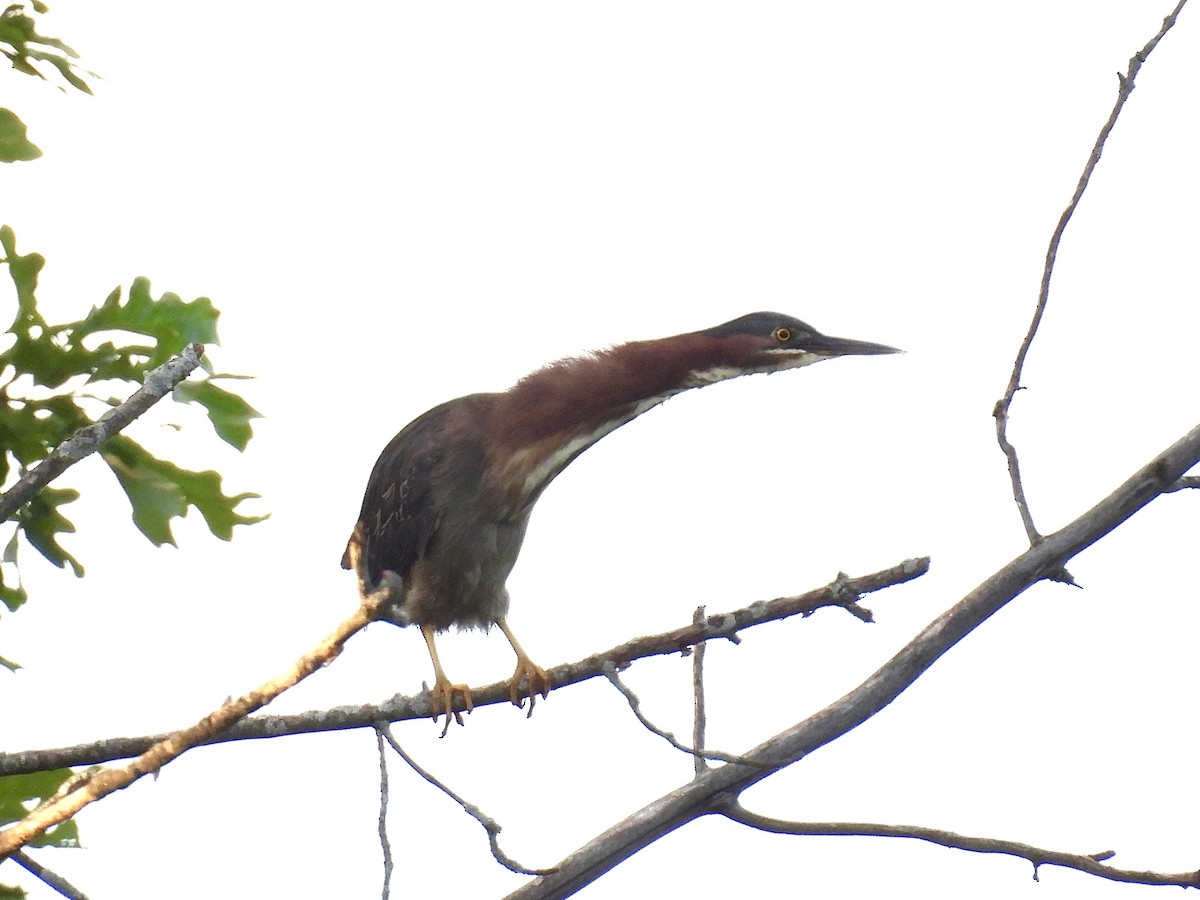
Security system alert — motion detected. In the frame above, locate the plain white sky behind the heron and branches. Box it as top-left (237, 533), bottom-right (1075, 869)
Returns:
top-left (0, 0), bottom-right (1200, 900)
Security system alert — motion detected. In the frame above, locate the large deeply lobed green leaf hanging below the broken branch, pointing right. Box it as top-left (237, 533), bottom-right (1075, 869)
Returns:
top-left (100, 434), bottom-right (266, 546)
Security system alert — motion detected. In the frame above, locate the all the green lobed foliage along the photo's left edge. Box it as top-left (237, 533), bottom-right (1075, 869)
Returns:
top-left (0, 8), bottom-right (263, 883)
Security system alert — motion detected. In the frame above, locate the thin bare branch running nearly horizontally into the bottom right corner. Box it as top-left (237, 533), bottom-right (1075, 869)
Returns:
top-left (720, 802), bottom-right (1200, 888)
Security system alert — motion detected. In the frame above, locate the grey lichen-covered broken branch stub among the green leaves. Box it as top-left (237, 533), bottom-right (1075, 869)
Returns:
top-left (0, 343), bottom-right (204, 522)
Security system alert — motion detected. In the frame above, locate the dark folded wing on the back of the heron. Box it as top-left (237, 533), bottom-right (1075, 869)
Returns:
top-left (342, 401), bottom-right (458, 588)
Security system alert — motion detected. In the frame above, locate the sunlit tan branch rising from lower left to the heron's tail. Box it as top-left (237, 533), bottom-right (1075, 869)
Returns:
top-left (0, 580), bottom-right (394, 859)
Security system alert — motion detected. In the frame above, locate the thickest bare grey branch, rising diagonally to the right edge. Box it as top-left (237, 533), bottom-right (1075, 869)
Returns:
top-left (509, 425), bottom-right (1200, 900)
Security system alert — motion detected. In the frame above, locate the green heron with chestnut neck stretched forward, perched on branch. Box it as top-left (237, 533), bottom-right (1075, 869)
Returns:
top-left (342, 312), bottom-right (898, 734)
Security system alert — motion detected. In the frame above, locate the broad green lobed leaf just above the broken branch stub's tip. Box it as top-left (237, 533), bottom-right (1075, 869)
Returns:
top-left (68, 276), bottom-right (221, 366)
